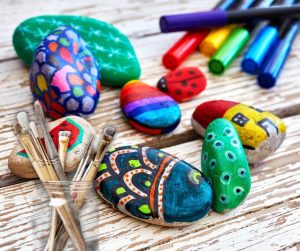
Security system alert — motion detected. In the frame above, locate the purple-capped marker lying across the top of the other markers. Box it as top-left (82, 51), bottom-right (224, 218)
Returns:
top-left (159, 5), bottom-right (300, 32)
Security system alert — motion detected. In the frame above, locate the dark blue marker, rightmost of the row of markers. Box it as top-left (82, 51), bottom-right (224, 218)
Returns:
top-left (257, 20), bottom-right (300, 88)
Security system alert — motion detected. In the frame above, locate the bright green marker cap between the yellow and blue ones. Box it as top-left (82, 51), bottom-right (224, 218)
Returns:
top-left (208, 27), bottom-right (250, 74)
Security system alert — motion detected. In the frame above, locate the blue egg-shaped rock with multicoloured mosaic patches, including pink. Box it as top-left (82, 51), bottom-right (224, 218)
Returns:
top-left (30, 26), bottom-right (101, 119)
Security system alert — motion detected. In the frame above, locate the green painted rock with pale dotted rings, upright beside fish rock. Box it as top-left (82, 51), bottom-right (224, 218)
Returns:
top-left (201, 119), bottom-right (251, 213)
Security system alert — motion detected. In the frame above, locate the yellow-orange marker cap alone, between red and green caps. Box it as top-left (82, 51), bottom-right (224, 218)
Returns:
top-left (199, 24), bottom-right (237, 57)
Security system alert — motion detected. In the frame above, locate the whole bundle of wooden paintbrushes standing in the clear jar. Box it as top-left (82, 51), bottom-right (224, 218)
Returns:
top-left (14, 102), bottom-right (115, 250)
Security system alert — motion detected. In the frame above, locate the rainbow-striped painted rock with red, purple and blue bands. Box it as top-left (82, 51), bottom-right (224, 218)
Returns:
top-left (120, 80), bottom-right (181, 135)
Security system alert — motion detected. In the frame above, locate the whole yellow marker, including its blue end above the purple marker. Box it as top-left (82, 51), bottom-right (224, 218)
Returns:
top-left (199, 0), bottom-right (258, 57)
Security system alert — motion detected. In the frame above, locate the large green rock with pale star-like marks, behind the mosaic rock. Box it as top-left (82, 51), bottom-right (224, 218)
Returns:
top-left (13, 15), bottom-right (141, 86)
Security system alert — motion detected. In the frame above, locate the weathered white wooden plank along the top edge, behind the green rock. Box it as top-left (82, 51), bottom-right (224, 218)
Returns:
top-left (0, 0), bottom-right (217, 61)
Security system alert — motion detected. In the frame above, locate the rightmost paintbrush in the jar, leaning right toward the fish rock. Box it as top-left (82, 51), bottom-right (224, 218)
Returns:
top-left (55, 126), bottom-right (116, 251)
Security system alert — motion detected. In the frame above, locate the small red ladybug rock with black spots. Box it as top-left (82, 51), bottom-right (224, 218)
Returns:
top-left (157, 67), bottom-right (206, 102)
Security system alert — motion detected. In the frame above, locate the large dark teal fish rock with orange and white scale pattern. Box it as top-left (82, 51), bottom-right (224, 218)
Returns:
top-left (95, 146), bottom-right (212, 226)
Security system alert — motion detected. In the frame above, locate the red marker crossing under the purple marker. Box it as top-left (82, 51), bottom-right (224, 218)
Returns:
top-left (162, 0), bottom-right (235, 70)
